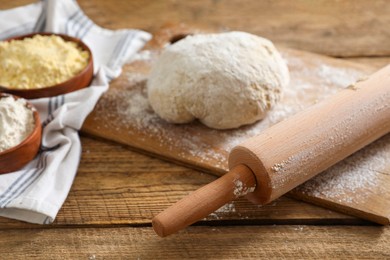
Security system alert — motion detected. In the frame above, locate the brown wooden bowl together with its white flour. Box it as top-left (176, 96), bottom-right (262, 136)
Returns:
top-left (0, 93), bottom-right (42, 174)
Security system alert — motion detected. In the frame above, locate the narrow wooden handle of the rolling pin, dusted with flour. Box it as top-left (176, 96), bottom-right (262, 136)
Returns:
top-left (152, 164), bottom-right (256, 237)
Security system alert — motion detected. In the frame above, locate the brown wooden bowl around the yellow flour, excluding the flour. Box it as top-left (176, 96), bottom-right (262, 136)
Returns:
top-left (0, 33), bottom-right (93, 99)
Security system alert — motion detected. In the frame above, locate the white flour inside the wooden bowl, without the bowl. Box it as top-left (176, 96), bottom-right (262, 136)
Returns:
top-left (0, 97), bottom-right (35, 152)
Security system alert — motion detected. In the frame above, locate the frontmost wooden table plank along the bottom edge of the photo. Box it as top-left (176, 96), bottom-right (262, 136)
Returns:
top-left (0, 226), bottom-right (390, 259)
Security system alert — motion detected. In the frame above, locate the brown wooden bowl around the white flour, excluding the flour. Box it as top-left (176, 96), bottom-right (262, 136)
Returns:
top-left (0, 93), bottom-right (42, 174)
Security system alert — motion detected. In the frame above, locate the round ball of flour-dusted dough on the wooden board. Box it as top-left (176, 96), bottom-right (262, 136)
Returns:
top-left (147, 32), bottom-right (289, 129)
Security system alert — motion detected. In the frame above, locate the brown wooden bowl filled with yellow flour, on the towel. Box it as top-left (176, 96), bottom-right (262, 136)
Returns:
top-left (0, 33), bottom-right (93, 99)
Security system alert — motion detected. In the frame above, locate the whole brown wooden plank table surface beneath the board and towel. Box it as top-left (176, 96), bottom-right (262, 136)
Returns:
top-left (0, 0), bottom-right (390, 259)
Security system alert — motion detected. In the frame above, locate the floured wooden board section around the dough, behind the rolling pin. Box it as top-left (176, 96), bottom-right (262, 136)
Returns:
top-left (82, 26), bottom-right (374, 175)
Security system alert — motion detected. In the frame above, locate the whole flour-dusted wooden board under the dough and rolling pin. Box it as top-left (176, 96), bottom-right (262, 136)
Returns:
top-left (82, 26), bottom-right (390, 224)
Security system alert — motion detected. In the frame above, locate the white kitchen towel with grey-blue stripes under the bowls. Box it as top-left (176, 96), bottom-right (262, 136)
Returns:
top-left (0, 0), bottom-right (150, 224)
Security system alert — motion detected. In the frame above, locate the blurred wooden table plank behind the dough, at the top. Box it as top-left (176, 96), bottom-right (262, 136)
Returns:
top-left (75, 0), bottom-right (390, 57)
